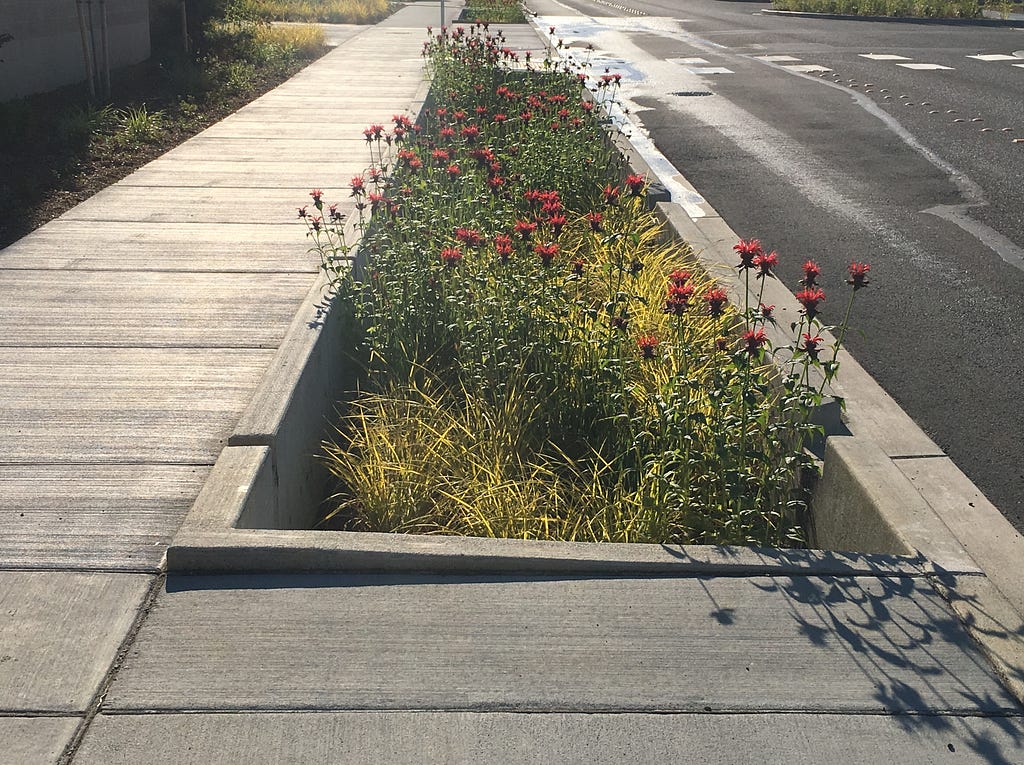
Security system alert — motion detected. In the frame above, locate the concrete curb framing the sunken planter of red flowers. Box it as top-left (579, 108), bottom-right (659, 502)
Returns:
top-left (167, 13), bottom-right (1024, 699)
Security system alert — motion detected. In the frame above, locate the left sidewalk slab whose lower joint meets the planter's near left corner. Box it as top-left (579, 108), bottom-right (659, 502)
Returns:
top-left (0, 464), bottom-right (210, 571)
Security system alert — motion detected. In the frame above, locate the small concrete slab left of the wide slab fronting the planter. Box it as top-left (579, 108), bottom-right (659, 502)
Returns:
top-left (0, 571), bottom-right (152, 714)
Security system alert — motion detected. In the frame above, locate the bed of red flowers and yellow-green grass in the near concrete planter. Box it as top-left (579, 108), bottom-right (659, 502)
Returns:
top-left (299, 25), bottom-right (868, 546)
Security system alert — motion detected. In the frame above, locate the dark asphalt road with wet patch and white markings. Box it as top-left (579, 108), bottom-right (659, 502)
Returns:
top-left (537, 0), bottom-right (1024, 532)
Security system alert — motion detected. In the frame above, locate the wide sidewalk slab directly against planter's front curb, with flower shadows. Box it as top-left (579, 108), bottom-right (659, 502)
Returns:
top-left (106, 576), bottom-right (1019, 714)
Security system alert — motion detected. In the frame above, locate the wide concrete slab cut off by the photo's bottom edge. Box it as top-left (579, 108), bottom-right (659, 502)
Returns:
top-left (75, 712), bottom-right (1024, 765)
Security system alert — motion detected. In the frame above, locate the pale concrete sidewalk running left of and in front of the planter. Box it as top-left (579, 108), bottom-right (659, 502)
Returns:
top-left (0, 3), bottom-right (1024, 765)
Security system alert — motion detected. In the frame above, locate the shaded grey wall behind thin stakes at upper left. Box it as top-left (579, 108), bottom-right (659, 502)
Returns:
top-left (0, 0), bottom-right (150, 101)
